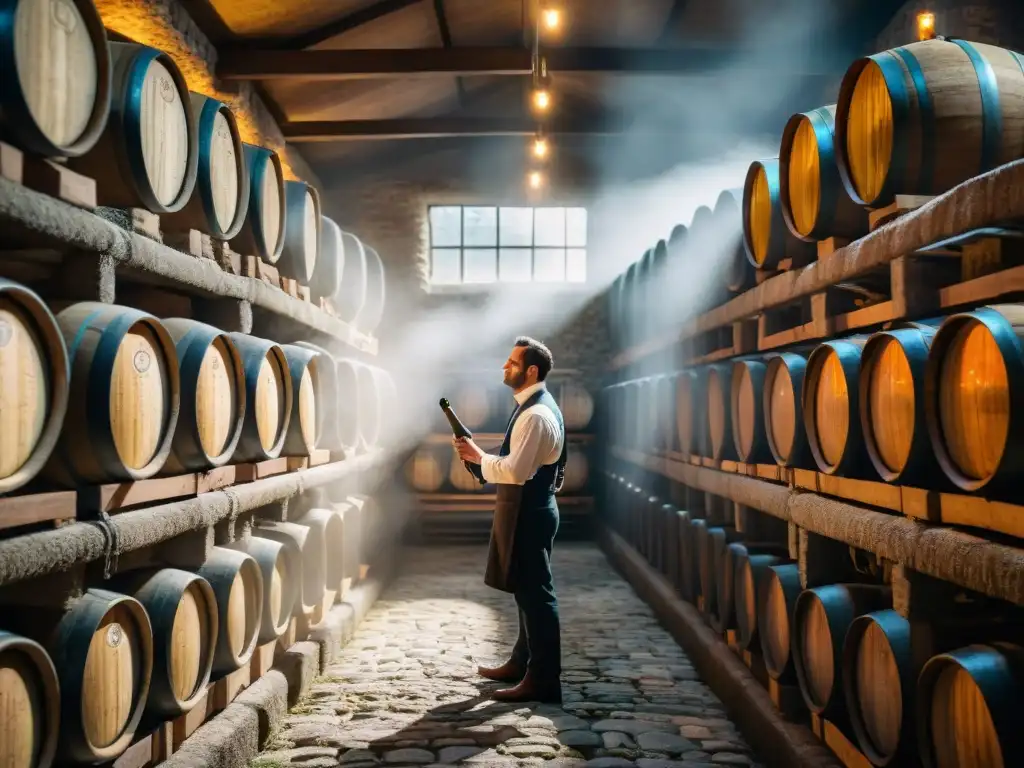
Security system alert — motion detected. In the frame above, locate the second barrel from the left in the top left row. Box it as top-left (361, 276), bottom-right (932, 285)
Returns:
top-left (68, 42), bottom-right (199, 213)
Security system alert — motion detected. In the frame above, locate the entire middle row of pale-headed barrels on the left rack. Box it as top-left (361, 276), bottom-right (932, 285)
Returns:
top-left (0, 280), bottom-right (394, 494)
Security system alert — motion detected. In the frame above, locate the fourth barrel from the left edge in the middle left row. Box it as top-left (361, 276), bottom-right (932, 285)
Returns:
top-left (228, 333), bottom-right (295, 462)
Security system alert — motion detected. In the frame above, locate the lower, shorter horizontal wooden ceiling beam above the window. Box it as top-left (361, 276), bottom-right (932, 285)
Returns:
top-left (281, 115), bottom-right (647, 142)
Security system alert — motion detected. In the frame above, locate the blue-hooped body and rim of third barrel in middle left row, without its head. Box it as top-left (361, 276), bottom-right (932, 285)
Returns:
top-left (174, 324), bottom-right (247, 470)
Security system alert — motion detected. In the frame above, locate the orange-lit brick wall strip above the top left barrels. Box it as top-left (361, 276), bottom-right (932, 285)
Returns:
top-left (95, 0), bottom-right (321, 187)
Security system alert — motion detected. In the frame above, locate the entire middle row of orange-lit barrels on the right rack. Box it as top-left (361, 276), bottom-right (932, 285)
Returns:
top-left (602, 304), bottom-right (1024, 501)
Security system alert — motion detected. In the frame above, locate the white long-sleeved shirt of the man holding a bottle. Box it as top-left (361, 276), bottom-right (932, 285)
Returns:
top-left (480, 381), bottom-right (562, 485)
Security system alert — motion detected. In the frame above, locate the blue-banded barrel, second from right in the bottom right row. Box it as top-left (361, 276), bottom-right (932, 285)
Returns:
top-left (843, 608), bottom-right (916, 766)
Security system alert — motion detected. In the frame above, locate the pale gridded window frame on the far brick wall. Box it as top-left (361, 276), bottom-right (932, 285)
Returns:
top-left (427, 201), bottom-right (591, 292)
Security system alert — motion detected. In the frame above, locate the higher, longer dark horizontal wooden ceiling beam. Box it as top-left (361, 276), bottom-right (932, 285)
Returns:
top-left (217, 45), bottom-right (834, 80)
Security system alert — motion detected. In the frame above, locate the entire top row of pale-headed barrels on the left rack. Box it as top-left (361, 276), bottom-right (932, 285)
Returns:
top-left (0, 0), bottom-right (385, 334)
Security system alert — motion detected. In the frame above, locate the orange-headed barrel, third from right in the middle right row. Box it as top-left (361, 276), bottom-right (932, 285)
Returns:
top-left (801, 336), bottom-right (870, 477)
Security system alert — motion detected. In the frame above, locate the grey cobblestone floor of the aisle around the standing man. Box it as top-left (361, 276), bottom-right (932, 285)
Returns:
top-left (252, 544), bottom-right (757, 768)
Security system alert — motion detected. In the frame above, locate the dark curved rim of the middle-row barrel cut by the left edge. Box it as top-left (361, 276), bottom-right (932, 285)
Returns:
top-left (0, 278), bottom-right (71, 494)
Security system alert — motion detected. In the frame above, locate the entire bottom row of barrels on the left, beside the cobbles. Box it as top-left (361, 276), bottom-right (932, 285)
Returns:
top-left (0, 496), bottom-right (377, 766)
